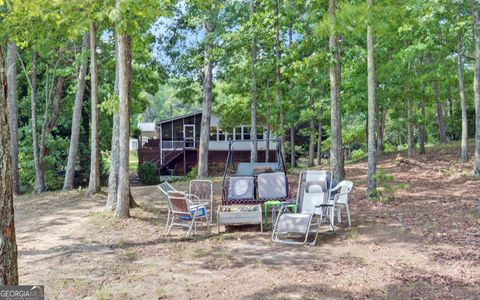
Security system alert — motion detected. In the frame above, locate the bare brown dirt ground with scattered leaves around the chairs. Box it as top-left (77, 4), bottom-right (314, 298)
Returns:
top-left (15, 147), bottom-right (480, 299)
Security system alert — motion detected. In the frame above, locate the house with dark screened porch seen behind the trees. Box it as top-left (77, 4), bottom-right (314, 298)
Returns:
top-left (138, 112), bottom-right (277, 175)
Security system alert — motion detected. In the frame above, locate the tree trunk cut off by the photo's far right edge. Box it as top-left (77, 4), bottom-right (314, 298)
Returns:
top-left (471, 0), bottom-right (480, 176)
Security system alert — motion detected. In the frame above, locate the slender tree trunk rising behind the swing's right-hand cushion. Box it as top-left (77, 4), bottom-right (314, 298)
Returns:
top-left (274, 0), bottom-right (287, 159)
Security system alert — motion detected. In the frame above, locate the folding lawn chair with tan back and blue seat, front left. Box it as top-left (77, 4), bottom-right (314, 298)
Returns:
top-left (167, 191), bottom-right (210, 237)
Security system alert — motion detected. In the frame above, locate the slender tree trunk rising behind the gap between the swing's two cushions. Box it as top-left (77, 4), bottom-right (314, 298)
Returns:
top-left (250, 0), bottom-right (258, 162)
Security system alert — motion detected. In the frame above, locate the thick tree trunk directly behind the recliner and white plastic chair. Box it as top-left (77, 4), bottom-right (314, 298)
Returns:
top-left (328, 0), bottom-right (345, 182)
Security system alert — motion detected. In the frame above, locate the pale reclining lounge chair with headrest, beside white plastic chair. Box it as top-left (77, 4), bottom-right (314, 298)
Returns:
top-left (272, 171), bottom-right (335, 245)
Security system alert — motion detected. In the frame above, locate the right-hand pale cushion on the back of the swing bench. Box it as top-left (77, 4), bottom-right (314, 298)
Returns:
top-left (257, 172), bottom-right (287, 199)
